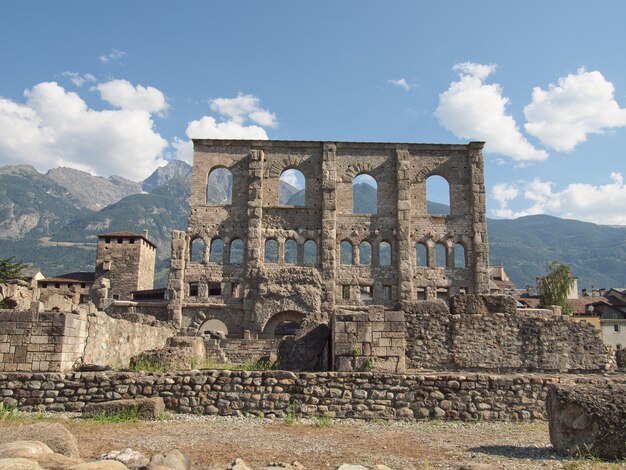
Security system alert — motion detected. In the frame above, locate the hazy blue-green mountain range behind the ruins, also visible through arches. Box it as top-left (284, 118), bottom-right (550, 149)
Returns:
top-left (0, 160), bottom-right (626, 287)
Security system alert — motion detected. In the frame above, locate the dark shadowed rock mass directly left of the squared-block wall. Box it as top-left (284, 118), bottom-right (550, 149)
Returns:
top-left (277, 322), bottom-right (330, 372)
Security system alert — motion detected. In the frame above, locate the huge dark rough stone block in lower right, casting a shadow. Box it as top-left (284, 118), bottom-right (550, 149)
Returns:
top-left (546, 384), bottom-right (626, 459)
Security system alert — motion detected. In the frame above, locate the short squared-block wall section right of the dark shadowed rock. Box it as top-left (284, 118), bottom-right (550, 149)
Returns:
top-left (332, 306), bottom-right (406, 373)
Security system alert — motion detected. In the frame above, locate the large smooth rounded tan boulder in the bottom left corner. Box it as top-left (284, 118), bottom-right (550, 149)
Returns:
top-left (0, 423), bottom-right (80, 457)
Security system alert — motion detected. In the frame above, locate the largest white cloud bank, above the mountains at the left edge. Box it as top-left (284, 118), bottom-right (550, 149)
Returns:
top-left (0, 82), bottom-right (167, 180)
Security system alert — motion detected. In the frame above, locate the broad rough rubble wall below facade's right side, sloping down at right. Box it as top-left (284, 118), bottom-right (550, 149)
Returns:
top-left (403, 295), bottom-right (613, 372)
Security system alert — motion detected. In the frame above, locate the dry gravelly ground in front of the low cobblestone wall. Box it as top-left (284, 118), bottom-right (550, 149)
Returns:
top-left (0, 415), bottom-right (626, 470)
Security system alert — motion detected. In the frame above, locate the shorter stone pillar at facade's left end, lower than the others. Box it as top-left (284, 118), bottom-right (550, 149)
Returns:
top-left (167, 230), bottom-right (189, 328)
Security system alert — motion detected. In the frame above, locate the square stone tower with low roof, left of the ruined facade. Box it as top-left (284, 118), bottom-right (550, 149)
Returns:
top-left (95, 232), bottom-right (156, 300)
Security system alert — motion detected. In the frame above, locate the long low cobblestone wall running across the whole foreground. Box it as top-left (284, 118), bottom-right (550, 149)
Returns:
top-left (0, 370), bottom-right (626, 420)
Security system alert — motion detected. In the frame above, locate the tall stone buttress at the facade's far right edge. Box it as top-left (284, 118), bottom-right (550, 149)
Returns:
top-left (467, 142), bottom-right (489, 294)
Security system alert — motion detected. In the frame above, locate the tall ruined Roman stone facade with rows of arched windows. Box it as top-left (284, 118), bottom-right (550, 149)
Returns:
top-left (168, 139), bottom-right (489, 337)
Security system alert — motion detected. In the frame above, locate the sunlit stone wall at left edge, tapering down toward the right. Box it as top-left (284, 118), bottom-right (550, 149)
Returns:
top-left (0, 302), bottom-right (175, 372)
